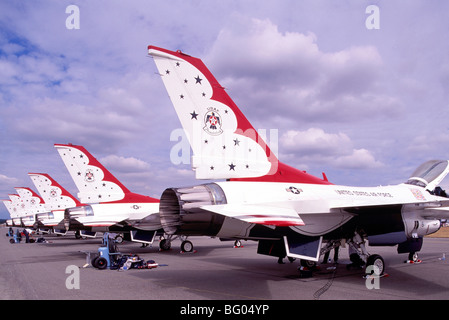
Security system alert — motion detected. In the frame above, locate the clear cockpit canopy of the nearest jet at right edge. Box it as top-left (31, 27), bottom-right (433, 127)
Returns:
top-left (406, 160), bottom-right (449, 190)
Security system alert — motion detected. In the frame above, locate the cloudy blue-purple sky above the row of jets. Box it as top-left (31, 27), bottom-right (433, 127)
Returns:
top-left (0, 0), bottom-right (449, 218)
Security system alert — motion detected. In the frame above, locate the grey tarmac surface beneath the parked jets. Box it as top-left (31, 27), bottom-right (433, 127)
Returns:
top-left (0, 228), bottom-right (449, 304)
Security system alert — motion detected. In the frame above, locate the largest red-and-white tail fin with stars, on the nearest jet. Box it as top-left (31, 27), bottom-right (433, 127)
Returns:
top-left (148, 46), bottom-right (329, 184)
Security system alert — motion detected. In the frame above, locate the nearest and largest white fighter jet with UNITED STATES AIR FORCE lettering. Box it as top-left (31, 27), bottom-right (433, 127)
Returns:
top-left (148, 46), bottom-right (449, 275)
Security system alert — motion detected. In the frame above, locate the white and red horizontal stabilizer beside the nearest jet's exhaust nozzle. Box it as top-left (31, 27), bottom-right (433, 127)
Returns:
top-left (200, 204), bottom-right (305, 227)
